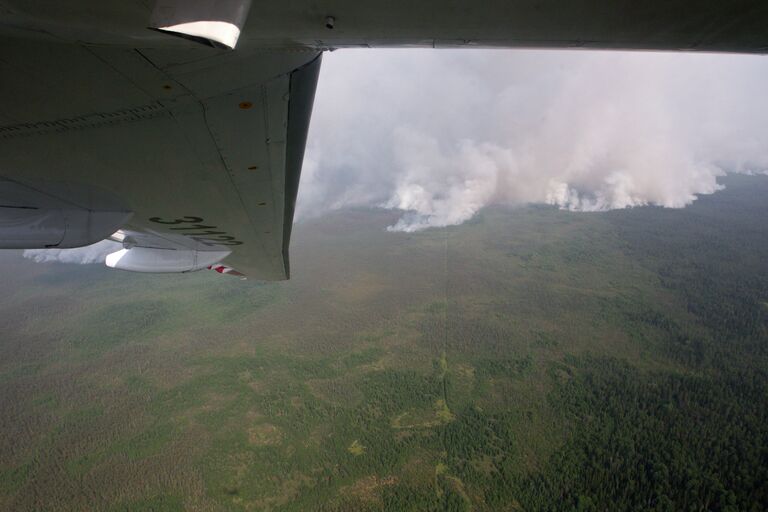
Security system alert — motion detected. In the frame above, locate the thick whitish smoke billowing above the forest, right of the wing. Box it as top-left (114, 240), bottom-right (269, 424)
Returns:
top-left (298, 50), bottom-right (768, 231)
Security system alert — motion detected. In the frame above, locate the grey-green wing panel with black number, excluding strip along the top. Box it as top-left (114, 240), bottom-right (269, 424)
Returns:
top-left (0, 35), bottom-right (320, 280)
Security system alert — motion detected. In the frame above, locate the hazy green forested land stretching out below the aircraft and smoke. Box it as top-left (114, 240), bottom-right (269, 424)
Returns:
top-left (0, 177), bottom-right (768, 511)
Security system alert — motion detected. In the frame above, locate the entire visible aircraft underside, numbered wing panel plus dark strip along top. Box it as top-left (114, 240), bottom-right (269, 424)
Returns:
top-left (0, 0), bottom-right (768, 280)
